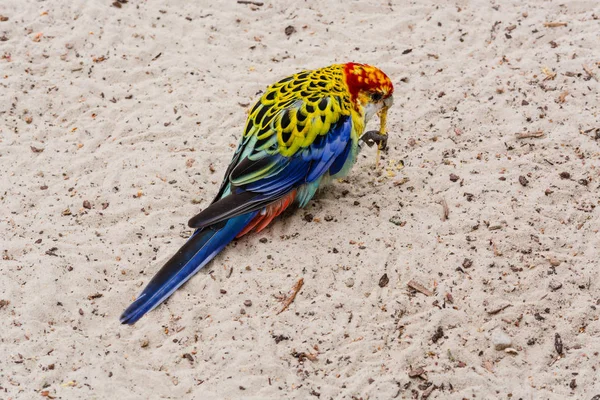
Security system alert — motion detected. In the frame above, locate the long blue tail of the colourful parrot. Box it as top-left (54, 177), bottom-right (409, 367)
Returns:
top-left (121, 211), bottom-right (258, 325)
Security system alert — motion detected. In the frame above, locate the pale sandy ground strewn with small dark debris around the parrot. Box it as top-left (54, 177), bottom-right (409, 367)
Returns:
top-left (0, 0), bottom-right (600, 400)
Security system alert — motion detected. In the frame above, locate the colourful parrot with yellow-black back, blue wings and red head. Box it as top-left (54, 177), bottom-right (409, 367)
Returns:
top-left (120, 62), bottom-right (394, 325)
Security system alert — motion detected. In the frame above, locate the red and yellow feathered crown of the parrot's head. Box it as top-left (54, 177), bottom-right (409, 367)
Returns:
top-left (344, 62), bottom-right (394, 101)
